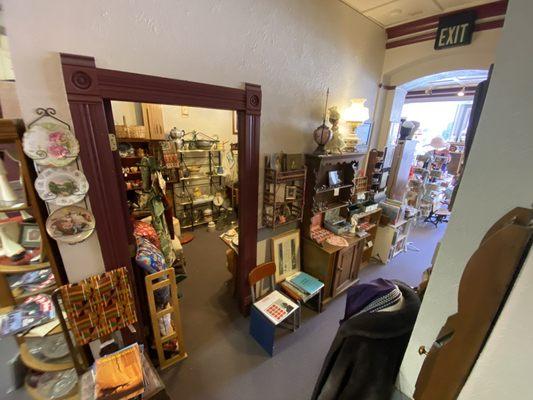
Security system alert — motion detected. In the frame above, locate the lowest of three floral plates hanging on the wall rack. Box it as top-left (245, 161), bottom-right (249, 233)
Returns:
top-left (46, 206), bottom-right (95, 244)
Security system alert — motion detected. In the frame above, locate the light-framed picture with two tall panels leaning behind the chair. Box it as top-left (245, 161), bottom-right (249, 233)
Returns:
top-left (272, 229), bottom-right (300, 283)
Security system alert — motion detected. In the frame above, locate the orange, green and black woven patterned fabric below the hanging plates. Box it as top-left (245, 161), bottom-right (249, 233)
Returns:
top-left (61, 268), bottom-right (137, 346)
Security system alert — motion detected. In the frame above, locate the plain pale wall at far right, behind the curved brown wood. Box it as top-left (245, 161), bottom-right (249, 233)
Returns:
top-left (399, 0), bottom-right (533, 400)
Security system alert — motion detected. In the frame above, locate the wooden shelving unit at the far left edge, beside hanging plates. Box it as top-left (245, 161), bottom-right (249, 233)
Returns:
top-left (0, 120), bottom-right (78, 400)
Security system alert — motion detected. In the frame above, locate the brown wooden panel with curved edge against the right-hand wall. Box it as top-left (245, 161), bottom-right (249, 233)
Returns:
top-left (414, 207), bottom-right (533, 400)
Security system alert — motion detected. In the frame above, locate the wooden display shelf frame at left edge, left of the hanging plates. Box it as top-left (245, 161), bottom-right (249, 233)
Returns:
top-left (0, 119), bottom-right (74, 399)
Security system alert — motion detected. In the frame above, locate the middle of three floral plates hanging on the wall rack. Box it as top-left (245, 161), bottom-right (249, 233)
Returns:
top-left (35, 168), bottom-right (89, 206)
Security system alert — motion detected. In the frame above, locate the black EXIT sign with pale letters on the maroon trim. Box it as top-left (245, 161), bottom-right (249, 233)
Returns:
top-left (435, 11), bottom-right (476, 50)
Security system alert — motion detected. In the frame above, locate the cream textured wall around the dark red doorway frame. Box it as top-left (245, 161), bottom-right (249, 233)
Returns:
top-left (3, 0), bottom-right (385, 275)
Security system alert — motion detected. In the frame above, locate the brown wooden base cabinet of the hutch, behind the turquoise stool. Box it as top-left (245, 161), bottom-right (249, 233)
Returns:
top-left (302, 237), bottom-right (364, 303)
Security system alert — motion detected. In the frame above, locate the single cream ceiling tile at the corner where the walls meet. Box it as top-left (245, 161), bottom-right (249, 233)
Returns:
top-left (365, 0), bottom-right (441, 27)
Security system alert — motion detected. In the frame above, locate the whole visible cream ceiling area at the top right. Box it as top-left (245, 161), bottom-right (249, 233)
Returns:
top-left (341, 0), bottom-right (494, 28)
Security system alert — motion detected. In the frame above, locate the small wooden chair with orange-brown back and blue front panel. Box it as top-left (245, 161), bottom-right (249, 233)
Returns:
top-left (248, 262), bottom-right (301, 356)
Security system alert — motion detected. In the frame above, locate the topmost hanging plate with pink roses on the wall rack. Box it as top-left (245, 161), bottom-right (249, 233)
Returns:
top-left (22, 123), bottom-right (80, 167)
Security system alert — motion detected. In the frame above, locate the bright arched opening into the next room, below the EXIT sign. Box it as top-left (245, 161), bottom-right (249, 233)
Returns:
top-left (360, 69), bottom-right (488, 296)
